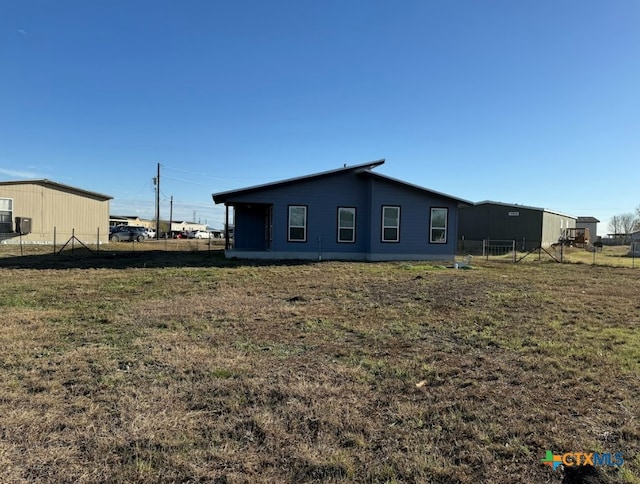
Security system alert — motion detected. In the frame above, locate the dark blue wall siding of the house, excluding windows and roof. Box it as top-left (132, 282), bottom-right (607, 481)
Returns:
top-left (225, 172), bottom-right (457, 260)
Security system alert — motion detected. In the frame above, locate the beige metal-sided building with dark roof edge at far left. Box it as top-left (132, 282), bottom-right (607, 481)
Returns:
top-left (0, 179), bottom-right (113, 245)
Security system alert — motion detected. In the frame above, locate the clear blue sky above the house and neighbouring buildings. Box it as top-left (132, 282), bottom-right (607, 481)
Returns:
top-left (0, 0), bottom-right (640, 233)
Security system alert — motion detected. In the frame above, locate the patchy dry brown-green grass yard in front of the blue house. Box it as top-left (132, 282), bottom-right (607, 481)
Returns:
top-left (0, 246), bottom-right (640, 483)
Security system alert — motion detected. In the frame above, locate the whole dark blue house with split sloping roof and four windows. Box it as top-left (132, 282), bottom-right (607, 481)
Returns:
top-left (213, 160), bottom-right (470, 261)
